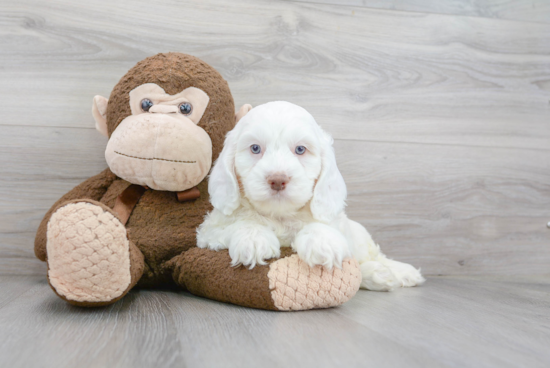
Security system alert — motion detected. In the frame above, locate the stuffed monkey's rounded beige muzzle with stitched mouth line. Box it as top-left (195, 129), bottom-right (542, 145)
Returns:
top-left (105, 113), bottom-right (212, 192)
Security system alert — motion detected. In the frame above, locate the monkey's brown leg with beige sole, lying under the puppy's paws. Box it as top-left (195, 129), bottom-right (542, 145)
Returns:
top-left (169, 248), bottom-right (361, 311)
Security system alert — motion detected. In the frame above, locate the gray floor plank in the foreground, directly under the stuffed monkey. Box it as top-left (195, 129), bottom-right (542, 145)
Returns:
top-left (0, 281), bottom-right (444, 367)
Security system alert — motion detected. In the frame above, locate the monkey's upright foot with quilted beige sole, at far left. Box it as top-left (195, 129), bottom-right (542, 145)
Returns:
top-left (46, 201), bottom-right (144, 307)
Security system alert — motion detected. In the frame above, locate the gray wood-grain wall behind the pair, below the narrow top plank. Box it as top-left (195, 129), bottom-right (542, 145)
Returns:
top-left (0, 0), bottom-right (550, 274)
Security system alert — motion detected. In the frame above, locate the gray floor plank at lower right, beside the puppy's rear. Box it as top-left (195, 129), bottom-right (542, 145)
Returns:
top-left (336, 277), bottom-right (550, 367)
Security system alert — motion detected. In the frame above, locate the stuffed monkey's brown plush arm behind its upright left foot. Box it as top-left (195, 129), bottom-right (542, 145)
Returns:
top-left (34, 169), bottom-right (116, 261)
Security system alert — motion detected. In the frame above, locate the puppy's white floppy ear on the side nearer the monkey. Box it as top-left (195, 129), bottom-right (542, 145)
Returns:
top-left (208, 128), bottom-right (241, 216)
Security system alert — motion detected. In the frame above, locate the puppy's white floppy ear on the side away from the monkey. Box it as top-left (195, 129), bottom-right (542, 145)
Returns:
top-left (310, 131), bottom-right (347, 222)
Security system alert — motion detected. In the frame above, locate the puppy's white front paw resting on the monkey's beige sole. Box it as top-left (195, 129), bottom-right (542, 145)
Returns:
top-left (292, 224), bottom-right (351, 270)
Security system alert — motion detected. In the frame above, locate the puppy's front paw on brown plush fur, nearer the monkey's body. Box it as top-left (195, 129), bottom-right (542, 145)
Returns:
top-left (228, 226), bottom-right (281, 268)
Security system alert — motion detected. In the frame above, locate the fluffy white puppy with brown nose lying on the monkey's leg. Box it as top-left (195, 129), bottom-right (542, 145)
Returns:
top-left (197, 102), bottom-right (424, 290)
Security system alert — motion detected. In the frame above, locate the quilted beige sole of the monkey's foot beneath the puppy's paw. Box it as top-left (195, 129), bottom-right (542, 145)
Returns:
top-left (267, 254), bottom-right (361, 311)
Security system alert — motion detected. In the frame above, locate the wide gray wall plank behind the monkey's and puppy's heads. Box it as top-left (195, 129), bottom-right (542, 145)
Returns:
top-left (0, 0), bottom-right (550, 149)
